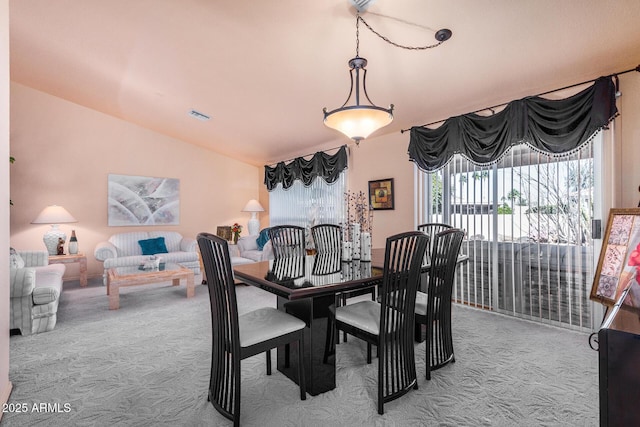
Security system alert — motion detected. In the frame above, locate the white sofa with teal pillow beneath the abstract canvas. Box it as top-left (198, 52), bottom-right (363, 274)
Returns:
top-left (93, 231), bottom-right (200, 285)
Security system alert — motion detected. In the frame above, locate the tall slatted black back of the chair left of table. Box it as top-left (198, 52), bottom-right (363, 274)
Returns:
top-left (197, 233), bottom-right (240, 420)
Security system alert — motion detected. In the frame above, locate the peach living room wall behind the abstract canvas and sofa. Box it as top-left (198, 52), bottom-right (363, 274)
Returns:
top-left (10, 83), bottom-right (261, 278)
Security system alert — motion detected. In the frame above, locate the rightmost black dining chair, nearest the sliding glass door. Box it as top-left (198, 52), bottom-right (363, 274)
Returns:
top-left (416, 228), bottom-right (464, 380)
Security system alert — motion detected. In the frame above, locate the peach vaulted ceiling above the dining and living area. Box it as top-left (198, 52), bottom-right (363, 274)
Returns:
top-left (9, 0), bottom-right (640, 165)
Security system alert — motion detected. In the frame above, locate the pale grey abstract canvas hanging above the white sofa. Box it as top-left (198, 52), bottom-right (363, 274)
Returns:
top-left (108, 174), bottom-right (180, 226)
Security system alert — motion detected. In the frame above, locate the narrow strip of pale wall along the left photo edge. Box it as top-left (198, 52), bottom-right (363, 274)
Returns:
top-left (0, 0), bottom-right (11, 420)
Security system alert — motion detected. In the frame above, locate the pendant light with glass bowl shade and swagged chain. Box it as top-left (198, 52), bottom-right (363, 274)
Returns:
top-left (322, 12), bottom-right (452, 145)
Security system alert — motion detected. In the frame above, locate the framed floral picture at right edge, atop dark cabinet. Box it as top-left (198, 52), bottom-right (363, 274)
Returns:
top-left (590, 208), bottom-right (640, 310)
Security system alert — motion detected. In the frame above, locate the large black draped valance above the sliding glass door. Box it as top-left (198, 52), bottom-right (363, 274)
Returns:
top-left (409, 77), bottom-right (618, 172)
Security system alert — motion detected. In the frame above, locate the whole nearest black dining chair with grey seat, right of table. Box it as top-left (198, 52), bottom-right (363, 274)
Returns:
top-left (325, 231), bottom-right (429, 414)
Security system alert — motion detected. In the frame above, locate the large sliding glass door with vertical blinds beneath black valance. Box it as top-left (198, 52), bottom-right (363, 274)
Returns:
top-left (416, 136), bottom-right (601, 329)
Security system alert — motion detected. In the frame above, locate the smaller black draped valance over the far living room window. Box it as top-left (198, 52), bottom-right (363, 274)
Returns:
top-left (264, 145), bottom-right (348, 191)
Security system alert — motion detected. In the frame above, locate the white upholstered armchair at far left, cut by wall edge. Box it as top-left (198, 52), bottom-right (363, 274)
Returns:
top-left (9, 250), bottom-right (65, 335)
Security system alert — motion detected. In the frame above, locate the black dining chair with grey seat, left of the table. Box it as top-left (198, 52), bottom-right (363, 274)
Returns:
top-left (197, 233), bottom-right (306, 426)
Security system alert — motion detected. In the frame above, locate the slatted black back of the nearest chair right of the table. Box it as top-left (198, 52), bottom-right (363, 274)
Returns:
top-left (378, 231), bottom-right (429, 413)
